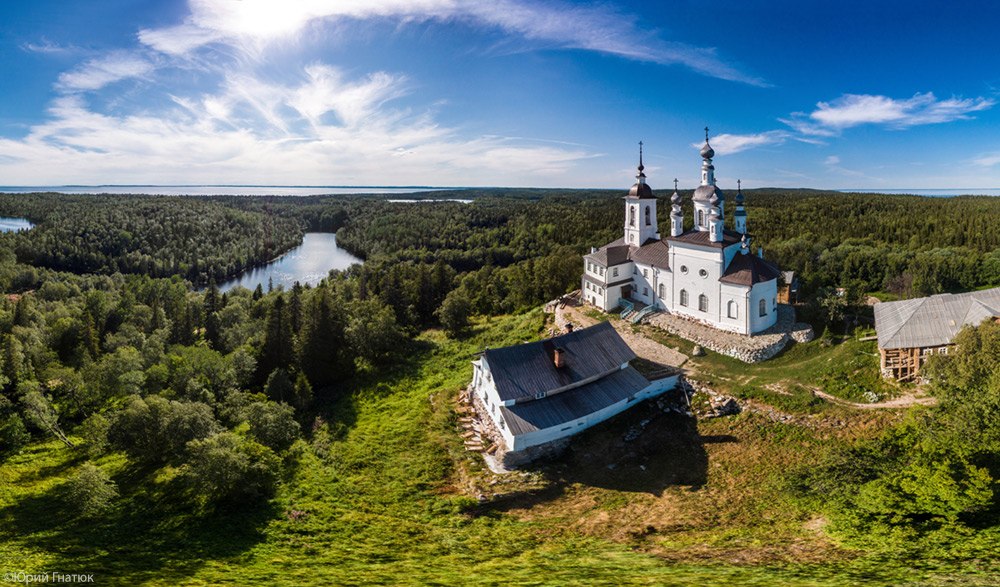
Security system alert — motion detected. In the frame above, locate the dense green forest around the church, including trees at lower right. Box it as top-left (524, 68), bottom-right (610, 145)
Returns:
top-left (0, 190), bottom-right (1000, 584)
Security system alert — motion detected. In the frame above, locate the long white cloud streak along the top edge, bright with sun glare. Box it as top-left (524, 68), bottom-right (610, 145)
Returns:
top-left (139, 0), bottom-right (767, 86)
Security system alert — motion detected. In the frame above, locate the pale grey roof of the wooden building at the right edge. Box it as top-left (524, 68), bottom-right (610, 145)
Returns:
top-left (874, 287), bottom-right (1000, 349)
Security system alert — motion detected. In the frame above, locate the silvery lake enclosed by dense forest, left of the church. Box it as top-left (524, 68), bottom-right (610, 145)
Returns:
top-left (219, 232), bottom-right (363, 291)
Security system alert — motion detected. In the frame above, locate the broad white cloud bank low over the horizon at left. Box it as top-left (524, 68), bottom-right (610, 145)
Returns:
top-left (0, 64), bottom-right (593, 185)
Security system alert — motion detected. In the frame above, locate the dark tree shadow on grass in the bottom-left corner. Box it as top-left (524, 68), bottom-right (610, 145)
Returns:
top-left (0, 467), bottom-right (278, 584)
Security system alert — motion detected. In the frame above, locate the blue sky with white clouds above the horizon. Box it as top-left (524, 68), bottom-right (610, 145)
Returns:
top-left (0, 0), bottom-right (1000, 189)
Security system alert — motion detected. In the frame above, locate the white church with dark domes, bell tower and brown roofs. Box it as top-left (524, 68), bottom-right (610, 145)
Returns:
top-left (581, 128), bottom-right (779, 335)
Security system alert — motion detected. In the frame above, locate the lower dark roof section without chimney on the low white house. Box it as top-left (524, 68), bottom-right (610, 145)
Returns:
top-left (500, 367), bottom-right (649, 435)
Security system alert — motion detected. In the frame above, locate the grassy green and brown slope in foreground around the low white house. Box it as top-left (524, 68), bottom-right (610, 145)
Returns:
top-left (0, 311), bottom-right (992, 585)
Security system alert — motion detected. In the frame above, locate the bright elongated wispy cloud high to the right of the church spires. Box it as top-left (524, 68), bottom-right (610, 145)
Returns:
top-left (781, 92), bottom-right (996, 136)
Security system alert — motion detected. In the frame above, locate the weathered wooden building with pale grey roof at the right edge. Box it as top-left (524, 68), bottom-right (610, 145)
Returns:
top-left (874, 287), bottom-right (1000, 381)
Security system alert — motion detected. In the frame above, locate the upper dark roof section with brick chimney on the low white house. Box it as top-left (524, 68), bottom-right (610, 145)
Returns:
top-left (483, 322), bottom-right (635, 401)
